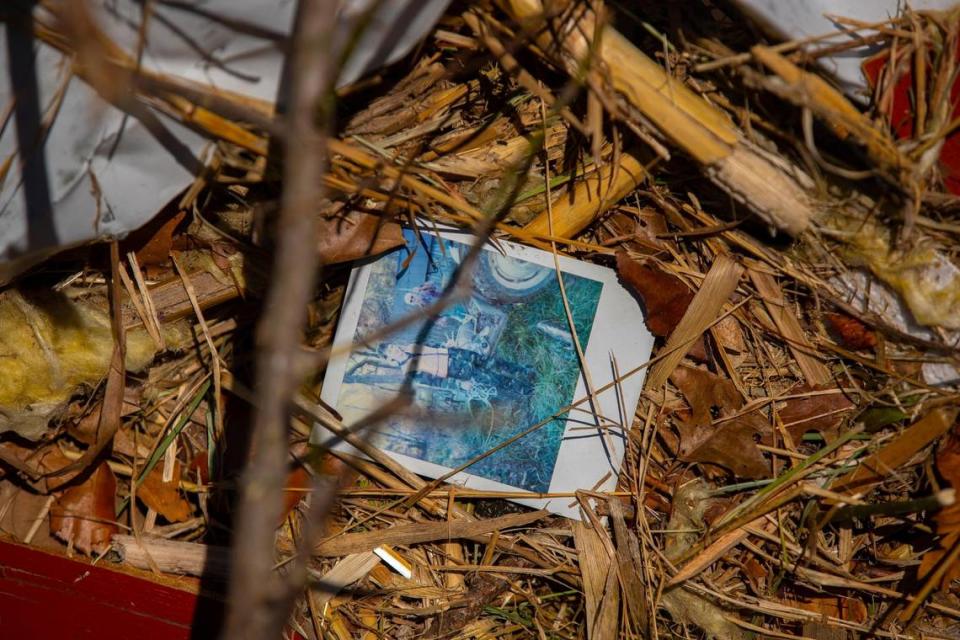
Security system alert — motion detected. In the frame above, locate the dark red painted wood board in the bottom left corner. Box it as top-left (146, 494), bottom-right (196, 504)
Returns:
top-left (0, 541), bottom-right (223, 640)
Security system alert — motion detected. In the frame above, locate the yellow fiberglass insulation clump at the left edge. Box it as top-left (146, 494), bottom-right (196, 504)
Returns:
top-left (0, 289), bottom-right (189, 440)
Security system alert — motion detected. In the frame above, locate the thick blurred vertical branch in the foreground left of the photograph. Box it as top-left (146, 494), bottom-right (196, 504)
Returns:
top-left (222, 0), bottom-right (338, 640)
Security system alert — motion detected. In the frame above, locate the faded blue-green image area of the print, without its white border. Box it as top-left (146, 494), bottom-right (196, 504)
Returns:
top-left (337, 230), bottom-right (603, 492)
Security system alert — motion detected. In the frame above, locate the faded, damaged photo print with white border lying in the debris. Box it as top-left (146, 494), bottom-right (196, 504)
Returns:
top-left (314, 229), bottom-right (653, 515)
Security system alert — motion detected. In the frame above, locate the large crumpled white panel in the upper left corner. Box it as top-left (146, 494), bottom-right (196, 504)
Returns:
top-left (0, 0), bottom-right (449, 283)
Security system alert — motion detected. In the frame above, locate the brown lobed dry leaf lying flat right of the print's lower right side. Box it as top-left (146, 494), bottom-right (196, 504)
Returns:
top-left (670, 367), bottom-right (772, 478)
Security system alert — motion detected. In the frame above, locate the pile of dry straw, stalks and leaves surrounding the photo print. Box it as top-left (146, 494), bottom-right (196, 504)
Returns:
top-left (0, 0), bottom-right (960, 639)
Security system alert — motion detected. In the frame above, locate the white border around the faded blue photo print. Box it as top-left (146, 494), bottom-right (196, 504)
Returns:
top-left (311, 227), bottom-right (654, 519)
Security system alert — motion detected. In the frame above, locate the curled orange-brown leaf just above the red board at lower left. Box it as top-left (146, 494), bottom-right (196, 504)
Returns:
top-left (50, 461), bottom-right (119, 554)
